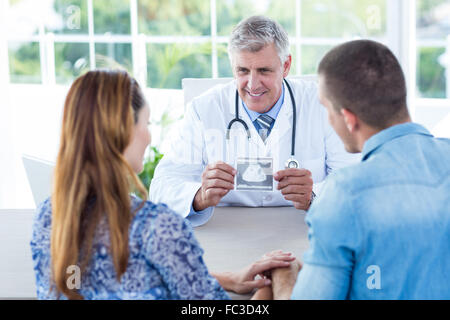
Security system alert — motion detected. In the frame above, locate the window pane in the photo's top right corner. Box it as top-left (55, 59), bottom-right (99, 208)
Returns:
top-left (417, 0), bottom-right (450, 39)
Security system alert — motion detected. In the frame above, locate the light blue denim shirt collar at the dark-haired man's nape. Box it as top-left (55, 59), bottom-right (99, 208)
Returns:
top-left (361, 122), bottom-right (432, 161)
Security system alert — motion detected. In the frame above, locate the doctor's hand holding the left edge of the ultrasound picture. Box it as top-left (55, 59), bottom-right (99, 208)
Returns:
top-left (192, 161), bottom-right (236, 211)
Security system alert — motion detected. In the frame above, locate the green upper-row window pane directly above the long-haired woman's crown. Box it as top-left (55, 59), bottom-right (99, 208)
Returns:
top-left (92, 0), bottom-right (131, 34)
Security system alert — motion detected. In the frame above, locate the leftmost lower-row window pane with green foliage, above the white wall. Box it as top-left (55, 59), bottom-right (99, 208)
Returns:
top-left (8, 42), bottom-right (41, 83)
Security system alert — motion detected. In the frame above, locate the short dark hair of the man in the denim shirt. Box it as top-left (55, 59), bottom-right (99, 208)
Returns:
top-left (319, 40), bottom-right (409, 129)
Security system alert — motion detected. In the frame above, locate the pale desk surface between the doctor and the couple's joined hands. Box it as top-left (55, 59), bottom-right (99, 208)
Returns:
top-left (195, 207), bottom-right (308, 299)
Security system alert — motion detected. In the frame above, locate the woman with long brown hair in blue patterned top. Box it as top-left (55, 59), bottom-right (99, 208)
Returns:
top-left (31, 71), bottom-right (294, 299)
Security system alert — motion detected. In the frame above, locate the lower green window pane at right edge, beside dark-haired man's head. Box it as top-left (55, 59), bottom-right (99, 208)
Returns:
top-left (417, 48), bottom-right (450, 98)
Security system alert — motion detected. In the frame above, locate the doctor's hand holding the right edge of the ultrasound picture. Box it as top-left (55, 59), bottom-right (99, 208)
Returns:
top-left (274, 169), bottom-right (313, 210)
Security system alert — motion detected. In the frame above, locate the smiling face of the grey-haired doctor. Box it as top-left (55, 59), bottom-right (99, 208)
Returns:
top-left (232, 43), bottom-right (292, 113)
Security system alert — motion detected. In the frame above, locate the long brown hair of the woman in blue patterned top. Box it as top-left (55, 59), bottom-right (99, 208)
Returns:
top-left (51, 71), bottom-right (147, 299)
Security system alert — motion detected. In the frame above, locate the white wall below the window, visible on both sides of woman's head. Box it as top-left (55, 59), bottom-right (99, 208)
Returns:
top-left (0, 82), bottom-right (183, 209)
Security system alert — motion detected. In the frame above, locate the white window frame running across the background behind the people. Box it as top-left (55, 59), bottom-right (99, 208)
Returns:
top-left (0, 0), bottom-right (450, 114)
